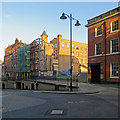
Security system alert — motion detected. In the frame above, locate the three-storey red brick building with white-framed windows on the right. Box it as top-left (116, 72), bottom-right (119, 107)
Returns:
top-left (86, 7), bottom-right (120, 82)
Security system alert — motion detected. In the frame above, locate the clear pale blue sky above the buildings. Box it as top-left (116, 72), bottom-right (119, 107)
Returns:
top-left (0, 2), bottom-right (118, 60)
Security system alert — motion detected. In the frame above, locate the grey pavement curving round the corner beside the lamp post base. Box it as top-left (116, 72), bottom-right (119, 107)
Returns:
top-left (35, 82), bottom-right (119, 94)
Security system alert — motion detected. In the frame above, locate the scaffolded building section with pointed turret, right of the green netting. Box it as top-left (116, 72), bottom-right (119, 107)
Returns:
top-left (30, 30), bottom-right (53, 76)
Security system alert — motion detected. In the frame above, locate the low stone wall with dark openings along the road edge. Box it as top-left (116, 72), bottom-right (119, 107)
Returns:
top-left (2, 81), bottom-right (77, 91)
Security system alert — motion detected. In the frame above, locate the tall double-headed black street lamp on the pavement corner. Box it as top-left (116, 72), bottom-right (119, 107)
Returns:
top-left (60, 13), bottom-right (81, 91)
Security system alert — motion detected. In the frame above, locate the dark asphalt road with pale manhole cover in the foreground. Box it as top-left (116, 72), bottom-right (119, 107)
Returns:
top-left (1, 85), bottom-right (119, 118)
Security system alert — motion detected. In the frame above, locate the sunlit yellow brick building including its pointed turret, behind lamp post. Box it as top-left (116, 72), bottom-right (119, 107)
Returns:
top-left (37, 31), bottom-right (88, 75)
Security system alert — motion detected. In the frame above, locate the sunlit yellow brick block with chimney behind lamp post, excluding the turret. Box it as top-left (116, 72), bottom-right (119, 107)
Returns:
top-left (50, 35), bottom-right (88, 75)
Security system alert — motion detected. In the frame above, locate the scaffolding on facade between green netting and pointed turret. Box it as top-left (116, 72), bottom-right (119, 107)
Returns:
top-left (30, 38), bottom-right (50, 77)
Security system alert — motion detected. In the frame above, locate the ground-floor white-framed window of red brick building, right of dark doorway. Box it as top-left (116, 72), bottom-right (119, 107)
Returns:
top-left (110, 63), bottom-right (118, 77)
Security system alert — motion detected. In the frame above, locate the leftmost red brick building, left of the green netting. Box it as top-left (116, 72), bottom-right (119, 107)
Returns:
top-left (4, 38), bottom-right (25, 79)
